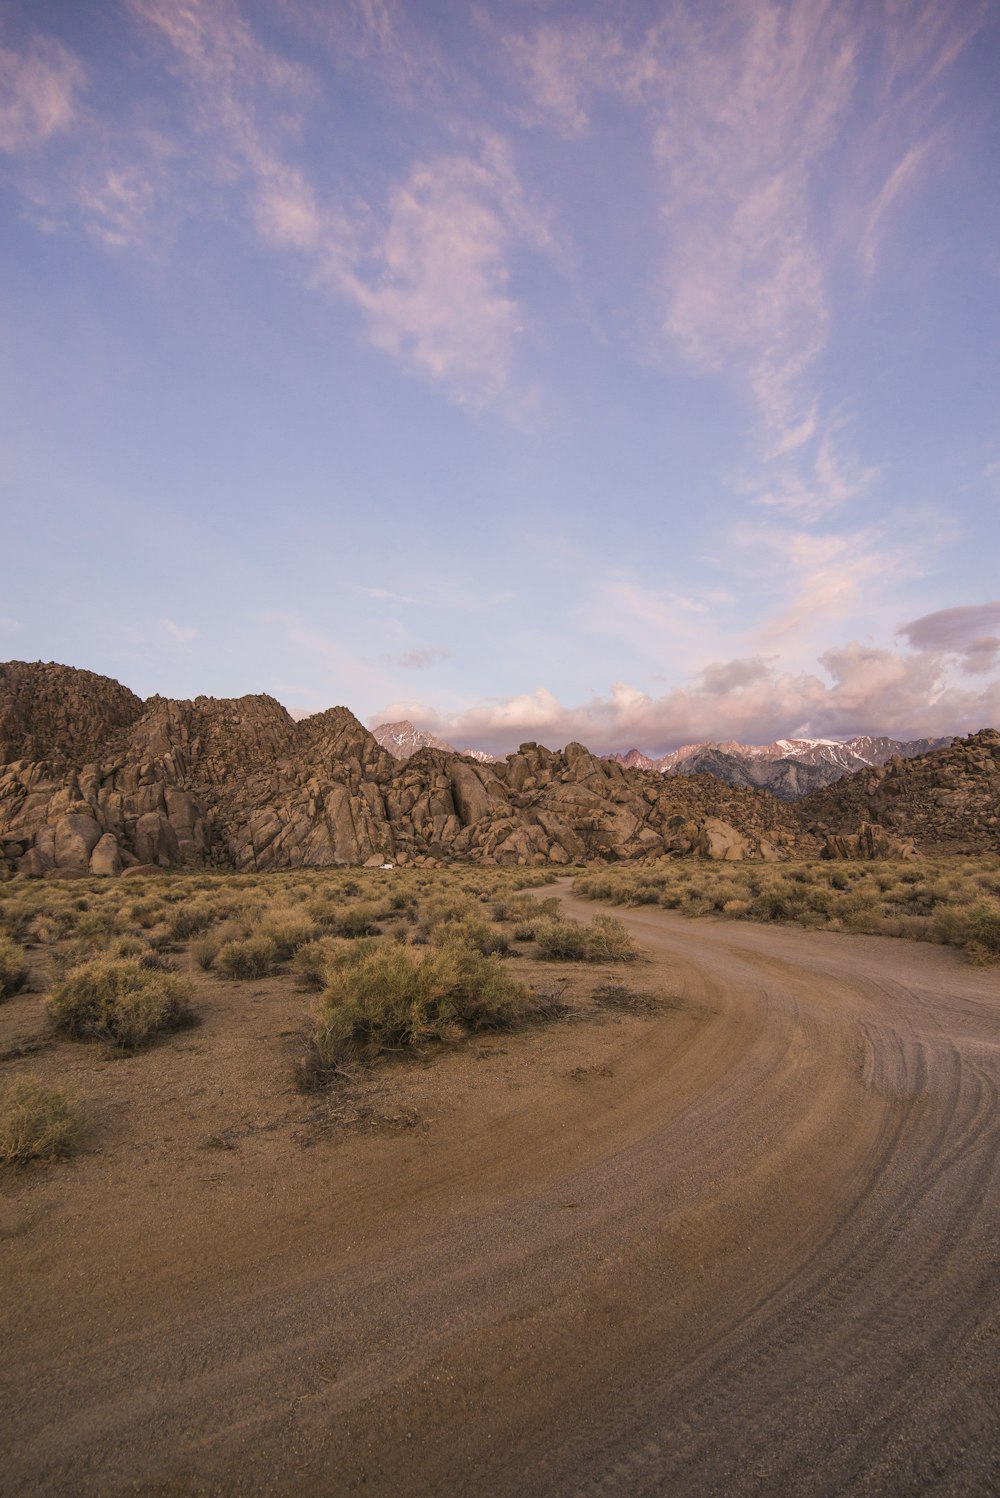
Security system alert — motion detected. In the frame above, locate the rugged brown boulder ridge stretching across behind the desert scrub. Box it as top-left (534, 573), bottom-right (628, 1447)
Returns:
top-left (0, 662), bottom-right (1000, 875)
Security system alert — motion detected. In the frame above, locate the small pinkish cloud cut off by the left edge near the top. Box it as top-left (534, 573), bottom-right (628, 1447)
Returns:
top-left (0, 36), bottom-right (84, 153)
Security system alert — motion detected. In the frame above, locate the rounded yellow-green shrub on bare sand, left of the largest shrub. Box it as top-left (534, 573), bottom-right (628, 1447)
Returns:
top-left (48, 956), bottom-right (192, 1050)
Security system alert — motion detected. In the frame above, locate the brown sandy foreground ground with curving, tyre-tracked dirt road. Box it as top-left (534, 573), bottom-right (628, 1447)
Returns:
top-left (0, 891), bottom-right (1000, 1498)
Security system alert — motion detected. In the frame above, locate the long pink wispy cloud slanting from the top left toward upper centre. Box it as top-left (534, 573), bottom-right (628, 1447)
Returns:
top-left (119, 0), bottom-right (548, 407)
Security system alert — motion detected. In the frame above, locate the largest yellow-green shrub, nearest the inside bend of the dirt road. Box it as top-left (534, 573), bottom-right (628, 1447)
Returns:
top-left (299, 942), bottom-right (531, 1085)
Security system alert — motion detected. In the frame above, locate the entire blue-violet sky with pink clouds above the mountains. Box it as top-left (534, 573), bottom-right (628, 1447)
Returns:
top-left (0, 0), bottom-right (1000, 753)
